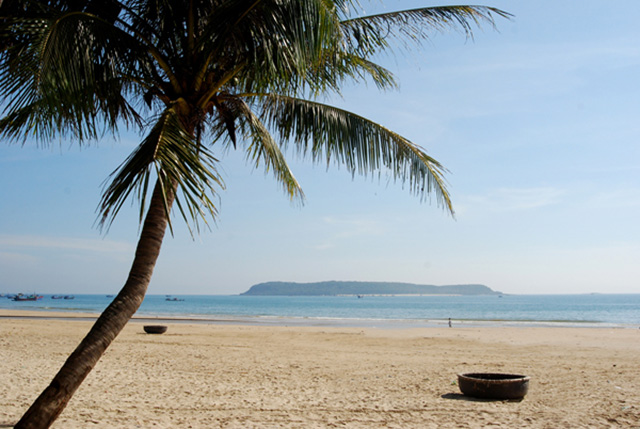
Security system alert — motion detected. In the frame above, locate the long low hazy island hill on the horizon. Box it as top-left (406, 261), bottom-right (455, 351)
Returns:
top-left (240, 281), bottom-right (501, 296)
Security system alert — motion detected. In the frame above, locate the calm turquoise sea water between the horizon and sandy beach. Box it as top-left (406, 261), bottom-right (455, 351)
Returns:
top-left (0, 294), bottom-right (640, 329)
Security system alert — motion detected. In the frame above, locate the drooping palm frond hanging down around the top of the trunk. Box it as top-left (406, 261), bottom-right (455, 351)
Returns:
top-left (98, 109), bottom-right (224, 233)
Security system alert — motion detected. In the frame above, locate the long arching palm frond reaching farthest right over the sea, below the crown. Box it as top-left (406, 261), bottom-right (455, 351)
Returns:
top-left (261, 95), bottom-right (453, 214)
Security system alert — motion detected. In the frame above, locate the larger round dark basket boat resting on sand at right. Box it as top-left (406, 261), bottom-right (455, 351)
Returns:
top-left (458, 373), bottom-right (529, 399)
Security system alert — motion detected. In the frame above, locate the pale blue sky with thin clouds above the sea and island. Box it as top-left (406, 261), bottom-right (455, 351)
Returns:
top-left (0, 0), bottom-right (640, 295)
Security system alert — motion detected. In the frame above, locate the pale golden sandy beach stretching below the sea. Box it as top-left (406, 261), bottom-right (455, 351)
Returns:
top-left (0, 310), bottom-right (640, 428)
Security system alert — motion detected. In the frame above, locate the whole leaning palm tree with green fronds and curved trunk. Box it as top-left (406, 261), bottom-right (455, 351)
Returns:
top-left (0, 0), bottom-right (508, 428)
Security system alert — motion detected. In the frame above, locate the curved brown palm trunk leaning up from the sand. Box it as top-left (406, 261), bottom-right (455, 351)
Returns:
top-left (15, 178), bottom-right (175, 429)
